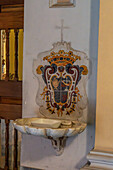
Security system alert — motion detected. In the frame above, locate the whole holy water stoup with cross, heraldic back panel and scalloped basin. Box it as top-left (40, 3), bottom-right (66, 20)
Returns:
top-left (14, 20), bottom-right (89, 156)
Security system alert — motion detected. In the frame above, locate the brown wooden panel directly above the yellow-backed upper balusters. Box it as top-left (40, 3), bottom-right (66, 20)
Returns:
top-left (0, 12), bottom-right (24, 29)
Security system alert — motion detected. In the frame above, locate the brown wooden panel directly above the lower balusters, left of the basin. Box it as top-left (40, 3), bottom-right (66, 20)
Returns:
top-left (0, 104), bottom-right (22, 120)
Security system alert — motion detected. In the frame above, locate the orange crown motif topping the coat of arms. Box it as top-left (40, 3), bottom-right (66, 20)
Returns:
top-left (43, 50), bottom-right (81, 66)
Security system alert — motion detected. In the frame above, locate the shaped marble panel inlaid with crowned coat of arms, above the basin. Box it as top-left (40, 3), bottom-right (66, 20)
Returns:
top-left (33, 42), bottom-right (89, 120)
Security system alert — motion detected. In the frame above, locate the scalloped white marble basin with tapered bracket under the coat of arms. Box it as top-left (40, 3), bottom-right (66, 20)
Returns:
top-left (13, 118), bottom-right (87, 155)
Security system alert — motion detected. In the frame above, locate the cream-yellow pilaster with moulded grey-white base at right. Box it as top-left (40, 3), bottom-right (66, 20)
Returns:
top-left (82, 0), bottom-right (113, 170)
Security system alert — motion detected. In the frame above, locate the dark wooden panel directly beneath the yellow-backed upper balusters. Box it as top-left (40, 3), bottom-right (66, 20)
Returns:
top-left (0, 81), bottom-right (22, 98)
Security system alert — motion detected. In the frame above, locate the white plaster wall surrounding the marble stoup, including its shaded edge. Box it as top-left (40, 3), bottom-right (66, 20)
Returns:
top-left (21, 0), bottom-right (99, 170)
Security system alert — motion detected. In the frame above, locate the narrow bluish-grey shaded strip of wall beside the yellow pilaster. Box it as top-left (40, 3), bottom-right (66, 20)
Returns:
top-left (76, 0), bottom-right (100, 169)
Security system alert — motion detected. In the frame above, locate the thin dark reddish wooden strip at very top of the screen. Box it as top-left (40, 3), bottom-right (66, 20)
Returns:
top-left (0, 0), bottom-right (24, 5)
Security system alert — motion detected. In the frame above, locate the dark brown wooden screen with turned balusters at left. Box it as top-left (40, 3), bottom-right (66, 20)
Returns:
top-left (0, 0), bottom-right (24, 170)
